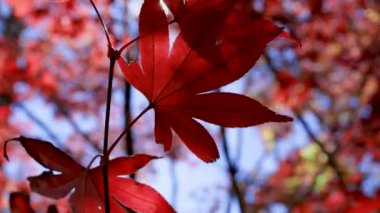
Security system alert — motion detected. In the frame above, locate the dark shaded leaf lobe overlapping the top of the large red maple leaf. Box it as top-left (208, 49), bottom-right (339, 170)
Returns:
top-left (164, 0), bottom-right (238, 59)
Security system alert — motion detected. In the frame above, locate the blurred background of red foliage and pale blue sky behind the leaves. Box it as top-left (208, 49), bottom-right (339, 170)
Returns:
top-left (0, 0), bottom-right (380, 213)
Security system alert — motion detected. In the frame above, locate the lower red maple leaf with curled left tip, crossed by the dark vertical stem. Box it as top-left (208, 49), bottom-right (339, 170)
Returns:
top-left (4, 136), bottom-right (174, 213)
